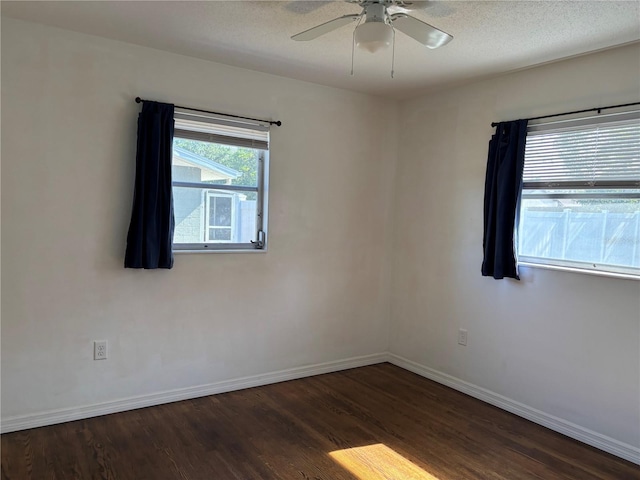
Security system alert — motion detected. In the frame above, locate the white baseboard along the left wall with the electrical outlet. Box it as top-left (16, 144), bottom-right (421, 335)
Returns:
top-left (0, 353), bottom-right (388, 433)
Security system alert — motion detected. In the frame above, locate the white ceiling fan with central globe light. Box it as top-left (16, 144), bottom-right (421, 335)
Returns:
top-left (291, 0), bottom-right (453, 53)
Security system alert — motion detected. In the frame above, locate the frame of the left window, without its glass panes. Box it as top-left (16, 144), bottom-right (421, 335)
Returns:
top-left (172, 108), bottom-right (269, 253)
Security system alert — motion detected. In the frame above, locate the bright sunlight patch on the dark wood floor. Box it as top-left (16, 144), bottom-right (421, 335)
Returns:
top-left (329, 443), bottom-right (438, 480)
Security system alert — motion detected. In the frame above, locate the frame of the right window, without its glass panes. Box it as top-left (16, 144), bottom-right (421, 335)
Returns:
top-left (514, 110), bottom-right (640, 280)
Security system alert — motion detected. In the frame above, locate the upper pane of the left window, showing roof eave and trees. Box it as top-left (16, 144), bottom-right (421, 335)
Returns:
top-left (173, 138), bottom-right (260, 188)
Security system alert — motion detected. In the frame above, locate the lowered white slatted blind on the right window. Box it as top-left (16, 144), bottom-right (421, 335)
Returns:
top-left (523, 112), bottom-right (640, 189)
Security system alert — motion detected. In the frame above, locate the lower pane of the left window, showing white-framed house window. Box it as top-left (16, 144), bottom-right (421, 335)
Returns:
top-left (173, 187), bottom-right (258, 244)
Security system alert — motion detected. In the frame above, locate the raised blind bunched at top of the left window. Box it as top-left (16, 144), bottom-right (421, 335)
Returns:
top-left (174, 109), bottom-right (269, 150)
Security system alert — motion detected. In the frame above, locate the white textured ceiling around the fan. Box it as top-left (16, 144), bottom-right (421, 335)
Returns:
top-left (1, 0), bottom-right (640, 98)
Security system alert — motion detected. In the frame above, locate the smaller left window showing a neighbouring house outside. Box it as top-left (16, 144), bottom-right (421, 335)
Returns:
top-left (172, 109), bottom-right (269, 251)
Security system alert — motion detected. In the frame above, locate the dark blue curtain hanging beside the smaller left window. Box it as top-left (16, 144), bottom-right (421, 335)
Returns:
top-left (124, 101), bottom-right (174, 268)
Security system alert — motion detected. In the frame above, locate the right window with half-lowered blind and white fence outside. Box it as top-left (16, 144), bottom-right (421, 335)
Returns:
top-left (516, 112), bottom-right (640, 276)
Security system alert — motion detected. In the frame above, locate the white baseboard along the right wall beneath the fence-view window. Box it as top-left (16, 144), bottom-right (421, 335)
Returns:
top-left (387, 353), bottom-right (640, 465)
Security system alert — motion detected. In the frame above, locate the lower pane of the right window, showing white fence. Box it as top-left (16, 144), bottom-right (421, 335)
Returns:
top-left (518, 190), bottom-right (640, 268)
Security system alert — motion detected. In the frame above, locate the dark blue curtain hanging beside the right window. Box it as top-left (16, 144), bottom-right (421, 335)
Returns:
top-left (482, 120), bottom-right (527, 280)
